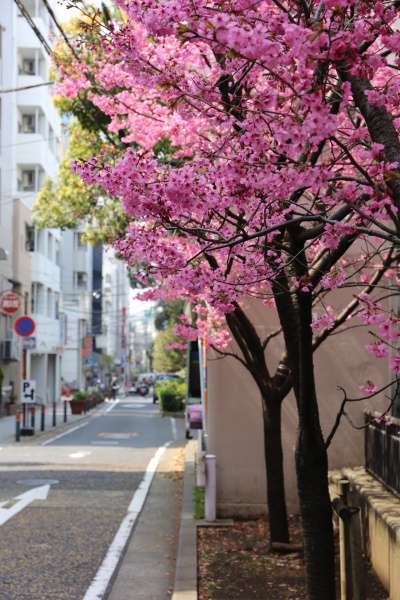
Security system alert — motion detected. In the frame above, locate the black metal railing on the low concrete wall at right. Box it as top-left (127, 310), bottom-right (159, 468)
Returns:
top-left (365, 412), bottom-right (400, 496)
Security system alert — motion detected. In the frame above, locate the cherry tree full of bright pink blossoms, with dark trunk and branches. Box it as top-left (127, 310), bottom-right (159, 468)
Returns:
top-left (53, 0), bottom-right (400, 600)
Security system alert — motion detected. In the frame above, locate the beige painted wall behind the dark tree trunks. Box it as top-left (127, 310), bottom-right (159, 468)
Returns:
top-left (208, 301), bottom-right (389, 516)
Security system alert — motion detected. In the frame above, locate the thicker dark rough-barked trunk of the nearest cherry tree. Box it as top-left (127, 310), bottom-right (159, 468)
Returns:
top-left (274, 232), bottom-right (335, 600)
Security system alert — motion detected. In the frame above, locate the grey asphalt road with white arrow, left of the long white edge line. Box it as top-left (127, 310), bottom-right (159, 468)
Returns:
top-left (0, 397), bottom-right (184, 600)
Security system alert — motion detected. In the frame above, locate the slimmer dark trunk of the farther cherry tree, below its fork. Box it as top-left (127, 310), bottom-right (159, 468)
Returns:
top-left (263, 399), bottom-right (290, 544)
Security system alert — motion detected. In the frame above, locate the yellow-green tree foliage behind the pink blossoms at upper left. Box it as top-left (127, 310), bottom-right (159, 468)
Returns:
top-left (33, 3), bottom-right (186, 245)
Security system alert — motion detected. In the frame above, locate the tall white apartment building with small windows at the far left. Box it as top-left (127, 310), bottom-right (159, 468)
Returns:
top-left (0, 0), bottom-right (62, 402)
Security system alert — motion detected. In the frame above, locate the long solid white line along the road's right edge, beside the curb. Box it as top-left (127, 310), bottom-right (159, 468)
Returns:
top-left (83, 442), bottom-right (171, 600)
